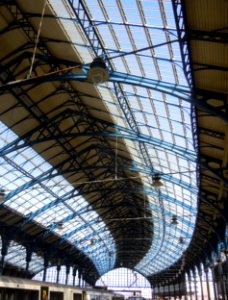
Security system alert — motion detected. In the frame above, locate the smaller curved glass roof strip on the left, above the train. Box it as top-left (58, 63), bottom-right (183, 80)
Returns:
top-left (0, 123), bottom-right (115, 273)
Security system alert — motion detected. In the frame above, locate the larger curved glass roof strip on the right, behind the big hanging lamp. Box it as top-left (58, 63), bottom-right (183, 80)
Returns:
top-left (47, 0), bottom-right (197, 275)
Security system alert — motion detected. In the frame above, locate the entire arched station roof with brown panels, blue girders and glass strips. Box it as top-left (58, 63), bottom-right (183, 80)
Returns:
top-left (0, 0), bottom-right (228, 284)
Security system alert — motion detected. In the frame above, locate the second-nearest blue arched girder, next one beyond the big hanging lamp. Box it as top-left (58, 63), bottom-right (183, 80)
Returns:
top-left (1, 101), bottom-right (220, 191)
